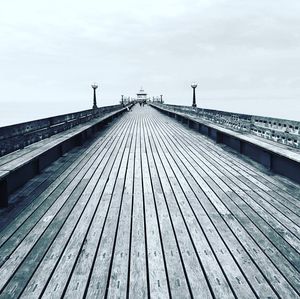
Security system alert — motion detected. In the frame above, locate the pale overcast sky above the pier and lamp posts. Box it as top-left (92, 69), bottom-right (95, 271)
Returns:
top-left (0, 0), bottom-right (300, 119)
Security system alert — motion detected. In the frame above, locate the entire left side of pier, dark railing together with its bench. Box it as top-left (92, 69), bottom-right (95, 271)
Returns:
top-left (0, 104), bottom-right (132, 208)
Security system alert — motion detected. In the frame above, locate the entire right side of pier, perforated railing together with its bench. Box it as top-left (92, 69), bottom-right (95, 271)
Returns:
top-left (151, 103), bottom-right (300, 183)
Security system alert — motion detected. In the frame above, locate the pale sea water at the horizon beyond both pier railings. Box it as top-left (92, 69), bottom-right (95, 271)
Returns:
top-left (0, 99), bottom-right (300, 127)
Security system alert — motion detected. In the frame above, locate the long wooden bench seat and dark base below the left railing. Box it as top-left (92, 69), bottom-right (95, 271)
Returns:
top-left (0, 107), bottom-right (131, 207)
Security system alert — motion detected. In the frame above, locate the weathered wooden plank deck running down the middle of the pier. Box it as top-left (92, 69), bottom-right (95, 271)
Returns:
top-left (0, 106), bottom-right (300, 299)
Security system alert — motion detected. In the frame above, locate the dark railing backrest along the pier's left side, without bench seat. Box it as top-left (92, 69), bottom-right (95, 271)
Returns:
top-left (0, 105), bottom-right (123, 157)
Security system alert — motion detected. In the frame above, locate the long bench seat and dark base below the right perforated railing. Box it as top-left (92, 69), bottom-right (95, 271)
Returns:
top-left (151, 105), bottom-right (300, 183)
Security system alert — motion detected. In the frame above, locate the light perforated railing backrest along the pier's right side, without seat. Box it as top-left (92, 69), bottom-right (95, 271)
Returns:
top-left (155, 103), bottom-right (300, 148)
